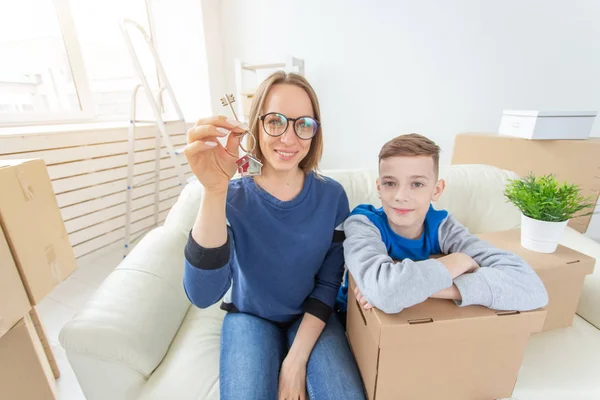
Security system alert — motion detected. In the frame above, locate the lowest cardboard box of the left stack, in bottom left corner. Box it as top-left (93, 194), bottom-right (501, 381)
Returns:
top-left (0, 316), bottom-right (56, 400)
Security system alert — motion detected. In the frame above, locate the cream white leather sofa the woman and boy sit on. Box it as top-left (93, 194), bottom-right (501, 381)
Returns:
top-left (60, 165), bottom-right (600, 400)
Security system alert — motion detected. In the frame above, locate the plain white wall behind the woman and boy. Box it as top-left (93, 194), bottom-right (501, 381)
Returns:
top-left (211, 0), bottom-right (600, 168)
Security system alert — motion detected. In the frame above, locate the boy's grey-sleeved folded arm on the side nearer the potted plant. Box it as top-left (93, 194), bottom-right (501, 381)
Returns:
top-left (439, 215), bottom-right (548, 311)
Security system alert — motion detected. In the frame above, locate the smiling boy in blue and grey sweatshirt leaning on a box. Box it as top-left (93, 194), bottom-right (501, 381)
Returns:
top-left (338, 134), bottom-right (548, 314)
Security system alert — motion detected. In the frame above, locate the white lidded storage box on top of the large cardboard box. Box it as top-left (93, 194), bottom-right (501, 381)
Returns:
top-left (499, 110), bottom-right (597, 140)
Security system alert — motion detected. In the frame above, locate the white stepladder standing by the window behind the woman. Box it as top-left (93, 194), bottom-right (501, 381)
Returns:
top-left (121, 19), bottom-right (187, 257)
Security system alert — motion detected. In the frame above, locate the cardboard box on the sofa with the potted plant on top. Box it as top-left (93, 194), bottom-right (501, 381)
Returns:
top-left (478, 229), bottom-right (596, 331)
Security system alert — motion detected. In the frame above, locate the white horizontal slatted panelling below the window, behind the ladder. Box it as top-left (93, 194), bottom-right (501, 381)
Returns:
top-left (0, 124), bottom-right (192, 257)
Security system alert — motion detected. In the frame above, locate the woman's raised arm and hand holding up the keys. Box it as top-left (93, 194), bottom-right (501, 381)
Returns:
top-left (183, 116), bottom-right (246, 308)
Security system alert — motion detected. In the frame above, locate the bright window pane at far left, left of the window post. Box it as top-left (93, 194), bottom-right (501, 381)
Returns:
top-left (0, 0), bottom-right (81, 119)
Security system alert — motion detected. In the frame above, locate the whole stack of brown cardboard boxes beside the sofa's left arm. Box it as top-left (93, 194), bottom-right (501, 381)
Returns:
top-left (0, 160), bottom-right (76, 399)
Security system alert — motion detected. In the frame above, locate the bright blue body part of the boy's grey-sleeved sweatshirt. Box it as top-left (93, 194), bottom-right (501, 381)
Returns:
top-left (336, 204), bottom-right (448, 311)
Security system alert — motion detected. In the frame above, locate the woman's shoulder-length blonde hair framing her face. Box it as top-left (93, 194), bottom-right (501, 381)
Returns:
top-left (248, 71), bottom-right (323, 172)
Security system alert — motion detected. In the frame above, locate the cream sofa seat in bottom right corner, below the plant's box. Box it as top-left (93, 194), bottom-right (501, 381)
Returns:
top-left (513, 316), bottom-right (600, 400)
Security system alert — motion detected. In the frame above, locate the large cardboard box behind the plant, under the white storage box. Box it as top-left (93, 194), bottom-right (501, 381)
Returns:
top-left (452, 133), bottom-right (600, 233)
